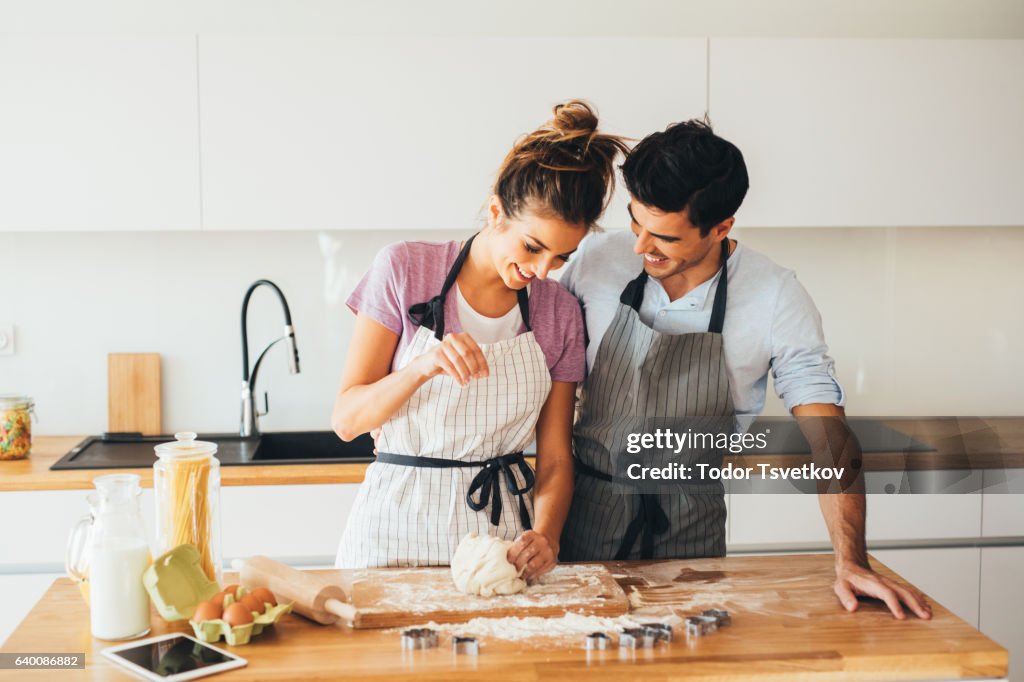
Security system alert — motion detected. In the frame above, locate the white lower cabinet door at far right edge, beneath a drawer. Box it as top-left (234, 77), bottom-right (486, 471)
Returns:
top-left (980, 547), bottom-right (1024, 682)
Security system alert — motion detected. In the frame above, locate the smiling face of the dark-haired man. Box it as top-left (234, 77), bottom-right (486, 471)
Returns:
top-left (629, 199), bottom-right (729, 283)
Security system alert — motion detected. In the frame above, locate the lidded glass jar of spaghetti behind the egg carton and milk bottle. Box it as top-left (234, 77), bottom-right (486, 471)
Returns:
top-left (153, 431), bottom-right (223, 585)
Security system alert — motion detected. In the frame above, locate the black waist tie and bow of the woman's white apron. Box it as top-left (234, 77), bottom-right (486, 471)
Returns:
top-left (377, 453), bottom-right (535, 530)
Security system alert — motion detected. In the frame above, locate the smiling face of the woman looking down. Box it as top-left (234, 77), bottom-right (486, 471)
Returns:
top-left (487, 197), bottom-right (587, 289)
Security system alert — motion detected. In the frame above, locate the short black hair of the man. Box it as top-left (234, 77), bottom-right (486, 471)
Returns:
top-left (622, 119), bottom-right (750, 237)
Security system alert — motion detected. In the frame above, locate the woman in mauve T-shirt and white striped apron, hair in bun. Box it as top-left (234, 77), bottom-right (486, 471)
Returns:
top-left (333, 101), bottom-right (626, 578)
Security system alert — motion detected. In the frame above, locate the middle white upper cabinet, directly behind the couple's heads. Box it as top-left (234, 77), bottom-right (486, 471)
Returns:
top-left (199, 35), bottom-right (707, 229)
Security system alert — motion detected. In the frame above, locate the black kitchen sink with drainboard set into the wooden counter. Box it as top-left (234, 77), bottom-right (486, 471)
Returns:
top-left (50, 431), bottom-right (374, 470)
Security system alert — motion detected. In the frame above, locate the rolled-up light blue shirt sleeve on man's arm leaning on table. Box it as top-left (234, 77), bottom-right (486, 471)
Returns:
top-left (771, 272), bottom-right (846, 412)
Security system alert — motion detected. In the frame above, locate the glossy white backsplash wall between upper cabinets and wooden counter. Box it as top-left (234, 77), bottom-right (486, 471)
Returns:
top-left (0, 224), bottom-right (1024, 434)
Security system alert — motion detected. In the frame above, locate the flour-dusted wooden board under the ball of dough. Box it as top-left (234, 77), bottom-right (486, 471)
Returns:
top-left (348, 563), bottom-right (630, 629)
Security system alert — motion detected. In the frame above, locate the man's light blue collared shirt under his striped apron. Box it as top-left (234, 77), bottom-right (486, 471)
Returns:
top-left (561, 230), bottom-right (846, 418)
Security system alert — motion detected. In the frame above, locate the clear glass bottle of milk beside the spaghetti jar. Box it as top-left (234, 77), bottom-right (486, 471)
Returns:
top-left (70, 474), bottom-right (151, 639)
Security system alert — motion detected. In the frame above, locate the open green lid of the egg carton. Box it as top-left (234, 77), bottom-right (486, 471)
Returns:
top-left (142, 545), bottom-right (220, 622)
